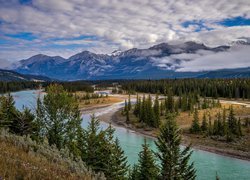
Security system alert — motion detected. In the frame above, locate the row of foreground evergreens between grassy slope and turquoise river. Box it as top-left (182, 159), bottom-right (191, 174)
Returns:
top-left (0, 85), bottom-right (196, 180)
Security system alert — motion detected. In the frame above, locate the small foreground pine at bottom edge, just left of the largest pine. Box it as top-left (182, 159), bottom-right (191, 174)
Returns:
top-left (137, 140), bottom-right (159, 180)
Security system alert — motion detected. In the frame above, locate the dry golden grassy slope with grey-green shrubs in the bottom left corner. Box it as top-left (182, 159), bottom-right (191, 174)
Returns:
top-left (0, 131), bottom-right (104, 180)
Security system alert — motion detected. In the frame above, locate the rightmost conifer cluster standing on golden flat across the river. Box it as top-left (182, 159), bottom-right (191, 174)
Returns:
top-left (190, 106), bottom-right (243, 142)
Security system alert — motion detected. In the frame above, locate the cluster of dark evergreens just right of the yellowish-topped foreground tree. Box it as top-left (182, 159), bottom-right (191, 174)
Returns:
top-left (78, 116), bottom-right (128, 180)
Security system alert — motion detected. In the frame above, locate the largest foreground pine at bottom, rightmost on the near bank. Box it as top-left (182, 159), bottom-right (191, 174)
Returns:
top-left (156, 118), bottom-right (196, 180)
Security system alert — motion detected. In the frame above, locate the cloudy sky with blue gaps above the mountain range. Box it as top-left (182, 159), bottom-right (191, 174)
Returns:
top-left (0, 0), bottom-right (250, 70)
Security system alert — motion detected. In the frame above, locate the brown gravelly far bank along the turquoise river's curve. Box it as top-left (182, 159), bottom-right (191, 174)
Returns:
top-left (99, 109), bottom-right (250, 161)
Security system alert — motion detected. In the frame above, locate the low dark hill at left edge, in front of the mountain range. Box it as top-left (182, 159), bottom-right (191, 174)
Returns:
top-left (0, 69), bottom-right (52, 82)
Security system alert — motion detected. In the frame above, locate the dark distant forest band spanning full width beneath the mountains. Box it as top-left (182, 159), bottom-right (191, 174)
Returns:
top-left (0, 78), bottom-right (250, 99)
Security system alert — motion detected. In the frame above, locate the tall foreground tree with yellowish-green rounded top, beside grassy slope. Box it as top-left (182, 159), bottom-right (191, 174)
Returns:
top-left (37, 85), bottom-right (82, 152)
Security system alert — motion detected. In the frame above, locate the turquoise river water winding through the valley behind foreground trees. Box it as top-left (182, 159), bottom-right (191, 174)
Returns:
top-left (12, 90), bottom-right (250, 180)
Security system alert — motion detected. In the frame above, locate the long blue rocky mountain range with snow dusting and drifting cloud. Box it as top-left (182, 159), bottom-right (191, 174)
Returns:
top-left (10, 41), bottom-right (247, 80)
